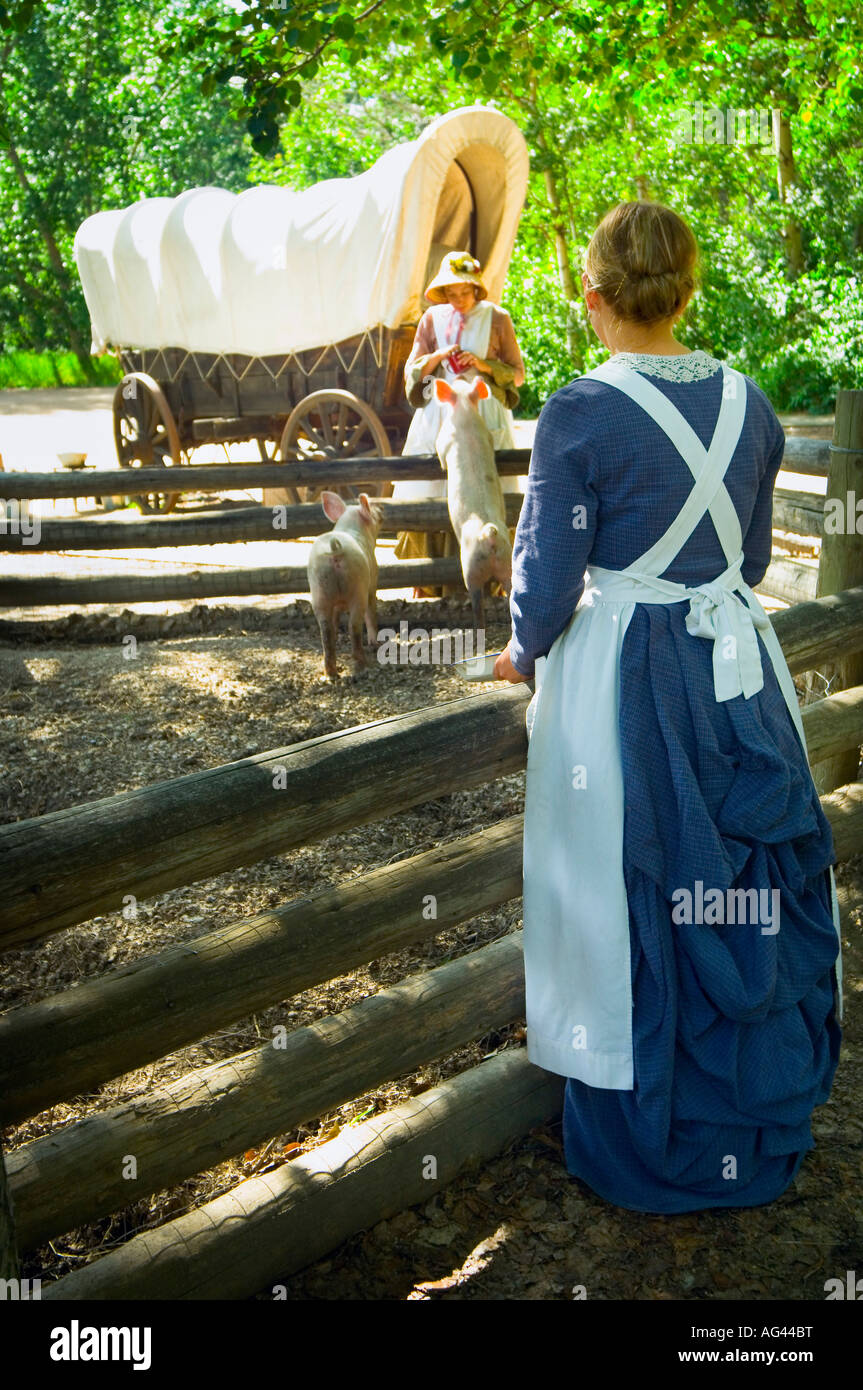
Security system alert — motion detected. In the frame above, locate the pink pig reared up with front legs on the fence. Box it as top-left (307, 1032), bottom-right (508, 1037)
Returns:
top-left (435, 377), bottom-right (513, 630)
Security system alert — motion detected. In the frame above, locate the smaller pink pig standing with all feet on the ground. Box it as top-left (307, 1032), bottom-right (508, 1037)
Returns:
top-left (309, 492), bottom-right (381, 680)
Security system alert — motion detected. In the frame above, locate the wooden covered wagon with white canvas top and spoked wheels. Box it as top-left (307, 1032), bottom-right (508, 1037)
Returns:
top-left (75, 106), bottom-right (528, 512)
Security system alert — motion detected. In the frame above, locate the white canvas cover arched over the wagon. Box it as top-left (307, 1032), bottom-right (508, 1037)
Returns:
top-left (75, 106), bottom-right (528, 357)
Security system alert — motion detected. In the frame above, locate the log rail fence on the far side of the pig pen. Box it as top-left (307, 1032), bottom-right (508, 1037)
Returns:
top-left (0, 430), bottom-right (856, 607)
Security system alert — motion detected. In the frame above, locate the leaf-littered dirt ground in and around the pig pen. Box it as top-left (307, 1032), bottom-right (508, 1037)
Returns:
top-left (0, 600), bottom-right (863, 1301)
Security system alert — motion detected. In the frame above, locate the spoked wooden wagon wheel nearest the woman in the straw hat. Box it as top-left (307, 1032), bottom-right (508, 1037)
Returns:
top-left (279, 391), bottom-right (392, 502)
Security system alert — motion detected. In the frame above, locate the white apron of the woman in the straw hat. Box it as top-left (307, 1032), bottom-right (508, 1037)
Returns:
top-left (392, 299), bottom-right (520, 502)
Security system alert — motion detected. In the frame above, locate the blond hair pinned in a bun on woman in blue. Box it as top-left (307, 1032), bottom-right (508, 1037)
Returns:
top-left (585, 203), bottom-right (698, 324)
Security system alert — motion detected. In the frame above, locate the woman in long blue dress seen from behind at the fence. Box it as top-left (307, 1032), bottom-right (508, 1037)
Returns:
top-left (495, 203), bottom-right (841, 1212)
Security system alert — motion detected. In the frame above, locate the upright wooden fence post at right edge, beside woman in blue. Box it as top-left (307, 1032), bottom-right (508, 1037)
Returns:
top-left (812, 391), bottom-right (863, 795)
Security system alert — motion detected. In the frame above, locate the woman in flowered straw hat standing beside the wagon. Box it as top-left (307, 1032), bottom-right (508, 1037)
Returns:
top-left (392, 252), bottom-right (524, 598)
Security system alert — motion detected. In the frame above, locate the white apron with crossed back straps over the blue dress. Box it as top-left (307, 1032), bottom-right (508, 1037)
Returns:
top-left (524, 359), bottom-right (841, 1091)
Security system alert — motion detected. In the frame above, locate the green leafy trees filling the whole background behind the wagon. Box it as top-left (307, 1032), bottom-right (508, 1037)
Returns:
top-left (0, 0), bottom-right (863, 409)
